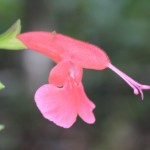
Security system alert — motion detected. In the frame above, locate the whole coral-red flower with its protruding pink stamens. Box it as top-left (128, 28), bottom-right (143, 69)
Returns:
top-left (18, 32), bottom-right (150, 128)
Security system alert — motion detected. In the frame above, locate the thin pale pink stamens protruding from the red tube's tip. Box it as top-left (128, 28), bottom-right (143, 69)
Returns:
top-left (108, 63), bottom-right (150, 100)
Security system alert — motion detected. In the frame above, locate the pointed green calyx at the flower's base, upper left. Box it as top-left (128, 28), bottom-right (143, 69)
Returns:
top-left (0, 20), bottom-right (26, 50)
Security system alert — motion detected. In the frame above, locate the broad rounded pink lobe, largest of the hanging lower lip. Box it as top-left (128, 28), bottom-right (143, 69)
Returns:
top-left (35, 84), bottom-right (77, 128)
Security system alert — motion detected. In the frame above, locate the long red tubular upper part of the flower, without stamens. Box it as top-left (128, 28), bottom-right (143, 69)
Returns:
top-left (17, 31), bottom-right (110, 70)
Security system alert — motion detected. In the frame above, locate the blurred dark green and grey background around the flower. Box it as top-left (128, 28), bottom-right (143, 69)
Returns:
top-left (0, 0), bottom-right (150, 150)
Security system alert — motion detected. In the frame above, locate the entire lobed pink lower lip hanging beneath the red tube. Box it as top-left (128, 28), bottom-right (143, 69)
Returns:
top-left (35, 61), bottom-right (95, 128)
